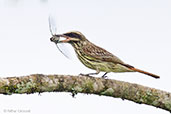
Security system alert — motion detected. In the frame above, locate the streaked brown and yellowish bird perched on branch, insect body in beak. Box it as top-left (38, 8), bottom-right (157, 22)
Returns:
top-left (50, 31), bottom-right (160, 79)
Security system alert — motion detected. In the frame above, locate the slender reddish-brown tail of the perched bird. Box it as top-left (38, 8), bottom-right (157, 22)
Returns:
top-left (120, 63), bottom-right (160, 78)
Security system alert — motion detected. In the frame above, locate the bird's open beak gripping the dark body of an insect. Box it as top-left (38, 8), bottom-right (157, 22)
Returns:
top-left (50, 34), bottom-right (79, 43)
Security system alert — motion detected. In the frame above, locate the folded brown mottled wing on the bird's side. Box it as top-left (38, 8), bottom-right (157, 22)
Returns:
top-left (83, 42), bottom-right (124, 64)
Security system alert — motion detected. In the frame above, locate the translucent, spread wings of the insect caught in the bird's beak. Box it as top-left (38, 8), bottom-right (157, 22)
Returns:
top-left (49, 16), bottom-right (71, 59)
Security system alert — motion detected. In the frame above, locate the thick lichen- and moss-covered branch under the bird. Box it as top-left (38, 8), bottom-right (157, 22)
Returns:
top-left (0, 74), bottom-right (171, 112)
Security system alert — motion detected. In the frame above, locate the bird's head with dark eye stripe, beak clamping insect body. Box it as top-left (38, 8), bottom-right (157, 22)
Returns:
top-left (50, 31), bottom-right (87, 44)
